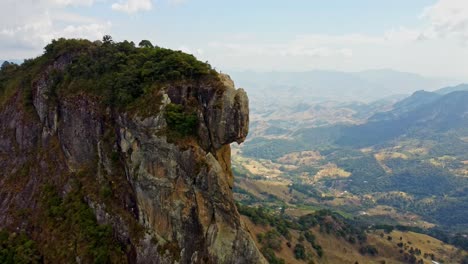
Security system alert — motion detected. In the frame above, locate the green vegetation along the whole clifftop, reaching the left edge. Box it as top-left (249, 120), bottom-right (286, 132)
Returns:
top-left (0, 36), bottom-right (220, 111)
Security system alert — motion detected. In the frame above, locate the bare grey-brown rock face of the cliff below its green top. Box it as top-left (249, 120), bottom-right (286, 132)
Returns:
top-left (0, 47), bottom-right (265, 263)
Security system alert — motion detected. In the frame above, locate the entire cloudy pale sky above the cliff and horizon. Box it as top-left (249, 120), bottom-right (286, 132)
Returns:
top-left (0, 0), bottom-right (468, 81)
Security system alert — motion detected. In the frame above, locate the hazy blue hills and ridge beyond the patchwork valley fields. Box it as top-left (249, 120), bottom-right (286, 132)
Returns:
top-left (244, 85), bottom-right (468, 159)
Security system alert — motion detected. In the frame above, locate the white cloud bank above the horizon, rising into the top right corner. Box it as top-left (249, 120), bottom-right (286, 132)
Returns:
top-left (182, 0), bottom-right (468, 77)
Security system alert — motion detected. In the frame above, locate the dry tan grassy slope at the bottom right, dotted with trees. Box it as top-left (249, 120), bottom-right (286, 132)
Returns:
top-left (242, 216), bottom-right (467, 264)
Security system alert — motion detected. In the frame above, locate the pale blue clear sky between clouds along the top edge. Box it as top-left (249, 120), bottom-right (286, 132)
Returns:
top-left (67, 0), bottom-right (436, 44)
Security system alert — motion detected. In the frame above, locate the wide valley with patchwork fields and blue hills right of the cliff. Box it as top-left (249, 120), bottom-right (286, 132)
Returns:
top-left (232, 86), bottom-right (468, 263)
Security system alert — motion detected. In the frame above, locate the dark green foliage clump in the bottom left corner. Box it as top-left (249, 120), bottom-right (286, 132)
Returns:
top-left (0, 230), bottom-right (43, 264)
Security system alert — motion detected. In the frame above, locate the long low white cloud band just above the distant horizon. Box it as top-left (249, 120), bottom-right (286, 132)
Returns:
top-left (201, 27), bottom-right (468, 79)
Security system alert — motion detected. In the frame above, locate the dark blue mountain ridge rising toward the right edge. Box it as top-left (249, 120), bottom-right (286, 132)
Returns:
top-left (337, 89), bottom-right (468, 146)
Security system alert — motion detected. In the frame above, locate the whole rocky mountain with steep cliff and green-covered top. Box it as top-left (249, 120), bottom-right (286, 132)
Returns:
top-left (0, 39), bottom-right (265, 263)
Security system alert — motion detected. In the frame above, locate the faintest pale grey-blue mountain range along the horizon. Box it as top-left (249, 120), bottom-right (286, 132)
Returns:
top-left (231, 69), bottom-right (455, 104)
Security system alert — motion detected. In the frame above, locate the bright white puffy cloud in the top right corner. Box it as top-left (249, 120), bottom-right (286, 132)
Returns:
top-left (421, 0), bottom-right (468, 44)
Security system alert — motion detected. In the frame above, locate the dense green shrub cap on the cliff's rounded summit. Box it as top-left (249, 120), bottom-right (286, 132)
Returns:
top-left (51, 36), bottom-right (217, 106)
